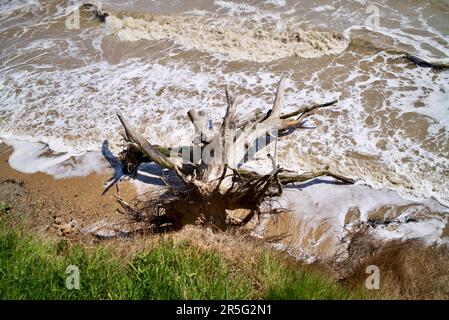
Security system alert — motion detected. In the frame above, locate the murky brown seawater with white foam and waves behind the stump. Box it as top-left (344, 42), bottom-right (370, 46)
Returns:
top-left (0, 0), bottom-right (449, 255)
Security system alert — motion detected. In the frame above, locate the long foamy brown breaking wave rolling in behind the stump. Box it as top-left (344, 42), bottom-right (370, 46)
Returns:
top-left (101, 14), bottom-right (347, 62)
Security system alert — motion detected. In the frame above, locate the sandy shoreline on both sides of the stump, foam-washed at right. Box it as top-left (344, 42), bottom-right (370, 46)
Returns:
top-left (0, 139), bottom-right (449, 262)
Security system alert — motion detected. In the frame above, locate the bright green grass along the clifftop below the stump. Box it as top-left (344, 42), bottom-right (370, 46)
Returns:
top-left (0, 205), bottom-right (351, 299)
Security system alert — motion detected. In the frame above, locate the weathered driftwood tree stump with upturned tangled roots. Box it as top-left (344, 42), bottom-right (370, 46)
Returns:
top-left (108, 77), bottom-right (354, 229)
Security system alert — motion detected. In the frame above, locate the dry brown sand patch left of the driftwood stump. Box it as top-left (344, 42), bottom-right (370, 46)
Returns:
top-left (0, 143), bottom-right (135, 236)
